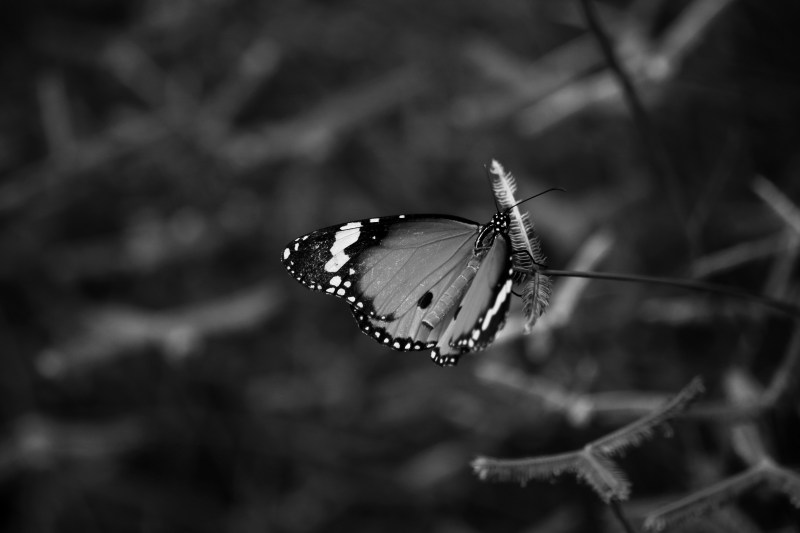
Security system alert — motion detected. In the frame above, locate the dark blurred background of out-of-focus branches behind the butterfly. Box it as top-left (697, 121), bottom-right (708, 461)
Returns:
top-left (0, 0), bottom-right (800, 533)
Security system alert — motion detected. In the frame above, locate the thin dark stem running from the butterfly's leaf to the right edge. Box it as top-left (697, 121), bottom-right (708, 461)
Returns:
top-left (540, 269), bottom-right (800, 319)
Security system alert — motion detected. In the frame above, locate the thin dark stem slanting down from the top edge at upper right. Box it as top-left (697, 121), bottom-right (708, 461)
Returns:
top-left (580, 0), bottom-right (694, 247)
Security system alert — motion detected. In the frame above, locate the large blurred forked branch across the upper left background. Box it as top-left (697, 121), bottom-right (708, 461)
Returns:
top-left (0, 40), bottom-right (427, 212)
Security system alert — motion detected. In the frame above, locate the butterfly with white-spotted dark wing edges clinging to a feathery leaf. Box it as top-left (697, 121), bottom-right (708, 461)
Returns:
top-left (281, 161), bottom-right (549, 366)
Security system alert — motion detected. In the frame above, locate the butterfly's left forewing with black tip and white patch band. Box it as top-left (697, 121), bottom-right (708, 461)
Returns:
top-left (282, 215), bottom-right (479, 320)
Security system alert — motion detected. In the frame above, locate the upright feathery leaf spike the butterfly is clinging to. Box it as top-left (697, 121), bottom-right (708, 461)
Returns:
top-left (488, 159), bottom-right (551, 333)
